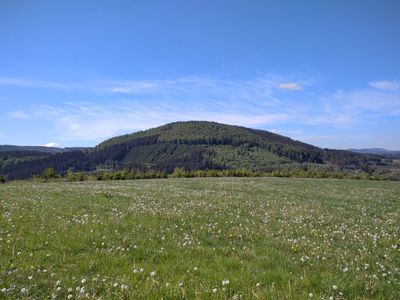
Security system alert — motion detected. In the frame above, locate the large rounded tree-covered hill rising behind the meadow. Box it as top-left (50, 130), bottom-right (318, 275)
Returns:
top-left (90, 121), bottom-right (380, 172)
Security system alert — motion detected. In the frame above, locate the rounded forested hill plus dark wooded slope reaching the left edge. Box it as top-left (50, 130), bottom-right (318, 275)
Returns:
top-left (0, 121), bottom-right (388, 178)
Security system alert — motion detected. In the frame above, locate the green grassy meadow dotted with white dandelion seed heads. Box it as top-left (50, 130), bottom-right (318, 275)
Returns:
top-left (0, 178), bottom-right (400, 299)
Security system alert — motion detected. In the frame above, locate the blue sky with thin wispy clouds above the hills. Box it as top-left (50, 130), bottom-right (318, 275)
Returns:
top-left (0, 0), bottom-right (400, 149)
